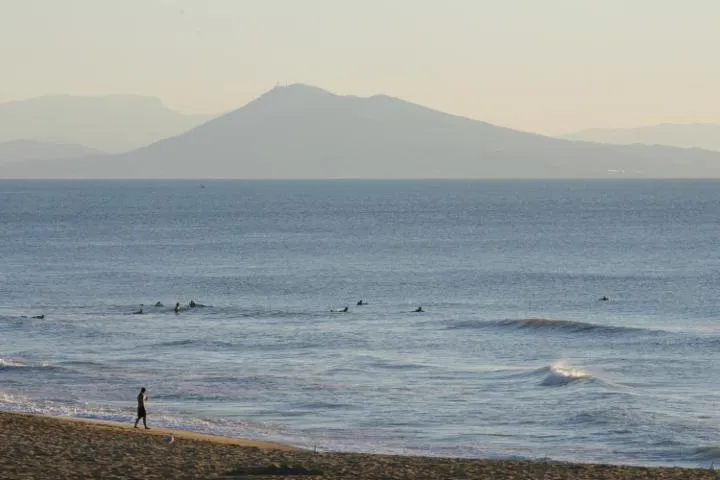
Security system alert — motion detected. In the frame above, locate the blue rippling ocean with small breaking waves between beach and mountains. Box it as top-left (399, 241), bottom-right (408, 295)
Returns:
top-left (0, 180), bottom-right (720, 466)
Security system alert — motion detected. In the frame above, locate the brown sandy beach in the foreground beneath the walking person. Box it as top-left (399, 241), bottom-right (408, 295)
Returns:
top-left (0, 412), bottom-right (720, 480)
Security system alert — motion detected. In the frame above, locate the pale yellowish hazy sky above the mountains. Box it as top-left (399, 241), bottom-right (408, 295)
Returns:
top-left (0, 0), bottom-right (720, 134)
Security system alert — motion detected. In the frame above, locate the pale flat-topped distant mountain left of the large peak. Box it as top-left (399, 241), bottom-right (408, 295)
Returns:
top-left (0, 95), bottom-right (211, 153)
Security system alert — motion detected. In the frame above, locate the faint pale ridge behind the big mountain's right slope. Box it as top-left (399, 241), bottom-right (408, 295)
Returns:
top-left (564, 123), bottom-right (720, 151)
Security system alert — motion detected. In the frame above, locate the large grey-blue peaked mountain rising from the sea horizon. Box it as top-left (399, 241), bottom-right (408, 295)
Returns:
top-left (0, 85), bottom-right (720, 179)
